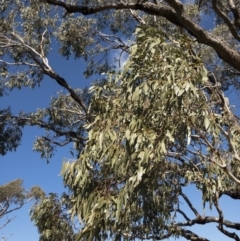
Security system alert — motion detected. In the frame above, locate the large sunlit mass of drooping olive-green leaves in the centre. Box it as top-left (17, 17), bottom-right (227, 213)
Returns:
top-left (58, 27), bottom-right (239, 240)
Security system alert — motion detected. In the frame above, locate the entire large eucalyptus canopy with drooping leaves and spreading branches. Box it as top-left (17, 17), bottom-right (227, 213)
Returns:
top-left (0, 0), bottom-right (240, 241)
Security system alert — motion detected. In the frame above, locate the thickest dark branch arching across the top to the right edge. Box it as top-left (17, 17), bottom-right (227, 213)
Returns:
top-left (45, 0), bottom-right (240, 71)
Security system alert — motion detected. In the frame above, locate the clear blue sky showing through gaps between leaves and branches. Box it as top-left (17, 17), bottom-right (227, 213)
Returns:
top-left (0, 10), bottom-right (240, 241)
